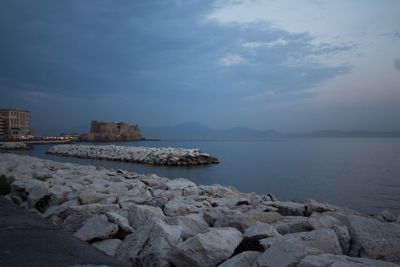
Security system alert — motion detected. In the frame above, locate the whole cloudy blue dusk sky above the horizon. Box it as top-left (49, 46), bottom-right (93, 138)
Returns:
top-left (0, 0), bottom-right (400, 134)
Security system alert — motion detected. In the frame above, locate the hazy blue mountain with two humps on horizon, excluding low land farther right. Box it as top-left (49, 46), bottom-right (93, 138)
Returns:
top-left (142, 122), bottom-right (279, 140)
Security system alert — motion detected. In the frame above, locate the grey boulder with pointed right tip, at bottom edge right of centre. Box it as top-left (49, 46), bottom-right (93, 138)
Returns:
top-left (253, 240), bottom-right (324, 267)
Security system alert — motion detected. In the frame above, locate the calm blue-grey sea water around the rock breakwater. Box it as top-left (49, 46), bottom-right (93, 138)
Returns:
top-left (12, 138), bottom-right (400, 215)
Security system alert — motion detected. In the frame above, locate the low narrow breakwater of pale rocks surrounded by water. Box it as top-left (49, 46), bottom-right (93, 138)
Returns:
top-left (47, 145), bottom-right (219, 165)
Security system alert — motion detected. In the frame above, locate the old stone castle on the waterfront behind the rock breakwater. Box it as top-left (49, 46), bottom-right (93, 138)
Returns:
top-left (81, 120), bottom-right (142, 142)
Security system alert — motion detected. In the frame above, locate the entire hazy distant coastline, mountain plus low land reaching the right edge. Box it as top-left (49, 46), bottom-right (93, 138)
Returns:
top-left (141, 122), bottom-right (400, 140)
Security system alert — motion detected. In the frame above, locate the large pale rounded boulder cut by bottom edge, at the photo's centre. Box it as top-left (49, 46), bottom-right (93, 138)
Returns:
top-left (171, 227), bottom-right (242, 267)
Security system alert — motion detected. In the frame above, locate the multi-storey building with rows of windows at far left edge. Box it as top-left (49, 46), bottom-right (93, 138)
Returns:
top-left (0, 109), bottom-right (31, 139)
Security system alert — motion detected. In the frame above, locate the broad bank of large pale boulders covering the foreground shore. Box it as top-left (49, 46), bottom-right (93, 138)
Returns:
top-left (0, 153), bottom-right (400, 267)
